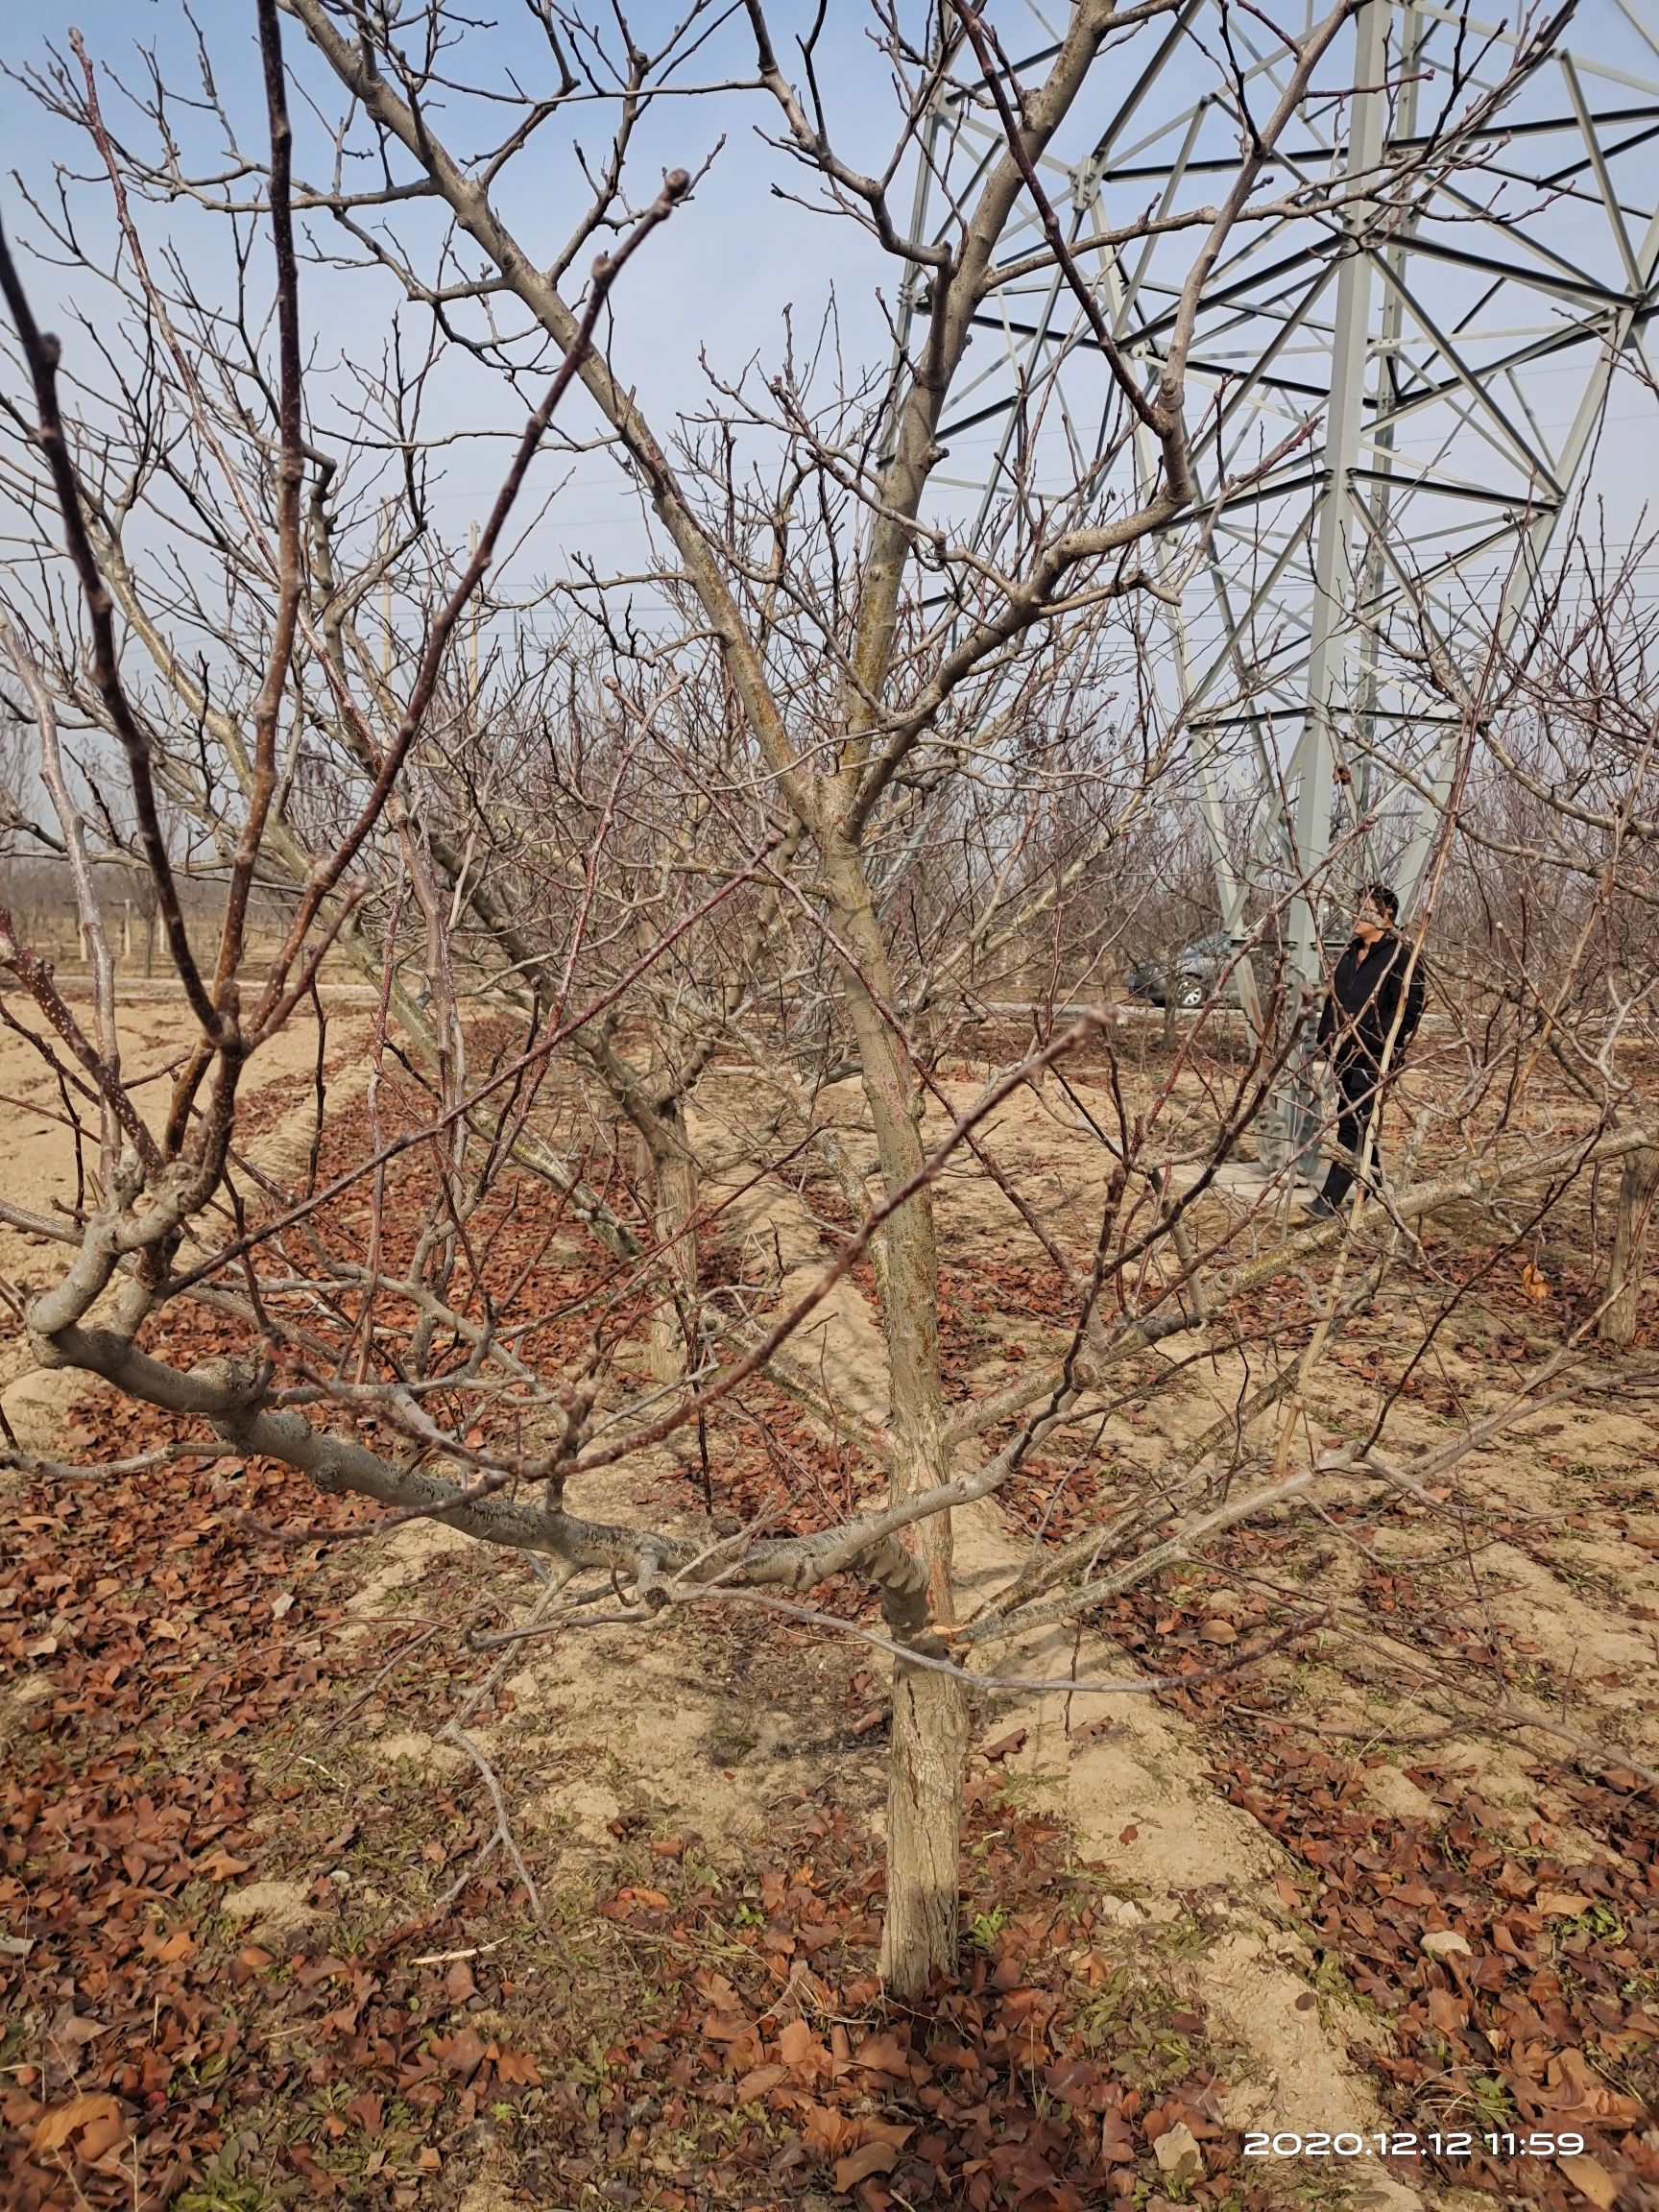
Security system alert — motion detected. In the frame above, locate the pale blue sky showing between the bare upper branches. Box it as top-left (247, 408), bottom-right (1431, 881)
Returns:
top-left (0, 0), bottom-right (1659, 645)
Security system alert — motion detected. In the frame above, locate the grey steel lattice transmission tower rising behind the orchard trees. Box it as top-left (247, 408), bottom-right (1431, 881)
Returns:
top-left (901, 0), bottom-right (1659, 1070)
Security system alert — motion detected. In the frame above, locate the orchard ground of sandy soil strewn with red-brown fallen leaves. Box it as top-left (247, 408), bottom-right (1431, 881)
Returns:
top-left (0, 1004), bottom-right (1659, 2212)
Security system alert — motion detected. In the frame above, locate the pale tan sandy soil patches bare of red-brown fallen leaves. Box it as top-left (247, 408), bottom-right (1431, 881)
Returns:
top-left (0, 1004), bottom-right (1659, 2212)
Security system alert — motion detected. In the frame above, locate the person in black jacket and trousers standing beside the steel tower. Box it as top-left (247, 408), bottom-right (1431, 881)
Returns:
top-left (1308, 882), bottom-right (1425, 1221)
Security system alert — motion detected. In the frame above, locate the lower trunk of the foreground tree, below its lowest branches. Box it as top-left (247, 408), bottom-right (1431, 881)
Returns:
top-left (880, 1661), bottom-right (969, 2000)
